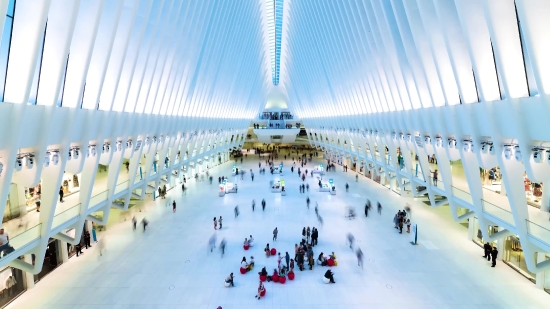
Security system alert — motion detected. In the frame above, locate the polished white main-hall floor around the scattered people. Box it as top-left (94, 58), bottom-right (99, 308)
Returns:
top-left (8, 155), bottom-right (550, 309)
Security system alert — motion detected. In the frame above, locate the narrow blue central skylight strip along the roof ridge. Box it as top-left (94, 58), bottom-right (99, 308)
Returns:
top-left (267, 0), bottom-right (284, 85)
